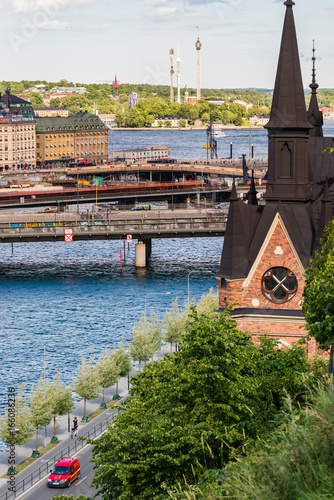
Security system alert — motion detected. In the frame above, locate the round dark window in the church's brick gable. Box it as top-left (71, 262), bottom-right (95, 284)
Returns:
top-left (262, 267), bottom-right (297, 304)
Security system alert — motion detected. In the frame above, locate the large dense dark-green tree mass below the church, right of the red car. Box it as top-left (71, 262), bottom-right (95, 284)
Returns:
top-left (89, 309), bottom-right (324, 500)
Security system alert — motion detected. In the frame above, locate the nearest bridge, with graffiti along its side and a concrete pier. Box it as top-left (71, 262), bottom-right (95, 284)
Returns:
top-left (0, 208), bottom-right (227, 267)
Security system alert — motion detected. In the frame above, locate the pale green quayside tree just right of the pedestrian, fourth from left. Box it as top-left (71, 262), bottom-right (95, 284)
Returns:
top-left (73, 351), bottom-right (101, 422)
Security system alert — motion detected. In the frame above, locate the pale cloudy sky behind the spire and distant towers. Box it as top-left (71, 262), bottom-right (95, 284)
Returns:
top-left (0, 0), bottom-right (334, 89)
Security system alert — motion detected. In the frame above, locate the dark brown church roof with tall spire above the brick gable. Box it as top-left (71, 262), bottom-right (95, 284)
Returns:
top-left (218, 0), bottom-right (334, 280)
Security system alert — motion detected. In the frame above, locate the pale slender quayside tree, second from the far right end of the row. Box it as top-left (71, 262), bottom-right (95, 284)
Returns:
top-left (163, 298), bottom-right (189, 354)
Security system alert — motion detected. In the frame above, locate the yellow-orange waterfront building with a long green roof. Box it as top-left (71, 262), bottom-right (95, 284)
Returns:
top-left (35, 112), bottom-right (109, 167)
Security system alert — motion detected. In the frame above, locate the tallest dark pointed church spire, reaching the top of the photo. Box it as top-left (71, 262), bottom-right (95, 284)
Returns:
top-left (265, 0), bottom-right (312, 202)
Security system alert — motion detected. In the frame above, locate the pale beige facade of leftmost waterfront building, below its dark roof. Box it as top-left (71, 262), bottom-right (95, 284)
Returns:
top-left (0, 114), bottom-right (36, 172)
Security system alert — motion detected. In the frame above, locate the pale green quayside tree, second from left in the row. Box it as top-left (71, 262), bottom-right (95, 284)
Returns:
top-left (29, 370), bottom-right (54, 457)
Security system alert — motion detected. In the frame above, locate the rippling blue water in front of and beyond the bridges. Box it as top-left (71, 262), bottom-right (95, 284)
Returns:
top-left (0, 121), bottom-right (334, 450)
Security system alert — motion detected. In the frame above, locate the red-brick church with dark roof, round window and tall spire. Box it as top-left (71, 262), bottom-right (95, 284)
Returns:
top-left (217, 0), bottom-right (334, 356)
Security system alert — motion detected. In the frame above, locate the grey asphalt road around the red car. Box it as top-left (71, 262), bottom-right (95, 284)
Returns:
top-left (18, 445), bottom-right (100, 500)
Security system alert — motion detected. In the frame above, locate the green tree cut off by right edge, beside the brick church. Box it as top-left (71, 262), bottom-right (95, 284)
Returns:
top-left (302, 221), bottom-right (334, 377)
